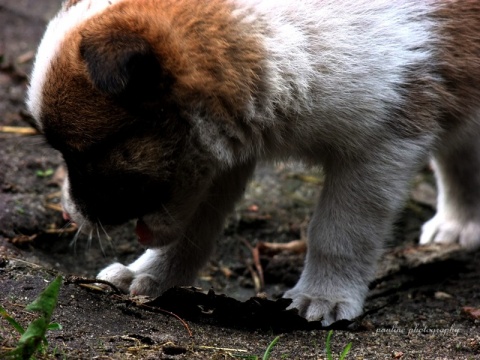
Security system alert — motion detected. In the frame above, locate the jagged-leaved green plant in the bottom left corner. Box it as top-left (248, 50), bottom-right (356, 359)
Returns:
top-left (0, 276), bottom-right (62, 360)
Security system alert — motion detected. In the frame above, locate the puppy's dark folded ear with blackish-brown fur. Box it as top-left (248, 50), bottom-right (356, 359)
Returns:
top-left (80, 30), bottom-right (162, 98)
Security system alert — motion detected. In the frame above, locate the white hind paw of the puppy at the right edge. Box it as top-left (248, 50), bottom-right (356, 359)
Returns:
top-left (420, 214), bottom-right (480, 249)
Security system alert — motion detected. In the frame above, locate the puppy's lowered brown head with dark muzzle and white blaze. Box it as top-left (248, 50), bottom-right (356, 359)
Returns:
top-left (27, 0), bottom-right (266, 246)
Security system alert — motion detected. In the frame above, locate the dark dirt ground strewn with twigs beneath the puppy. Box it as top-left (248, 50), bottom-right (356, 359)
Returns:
top-left (0, 0), bottom-right (480, 359)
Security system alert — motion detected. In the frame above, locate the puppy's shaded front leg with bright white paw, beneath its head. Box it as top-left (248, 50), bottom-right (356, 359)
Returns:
top-left (97, 162), bottom-right (255, 296)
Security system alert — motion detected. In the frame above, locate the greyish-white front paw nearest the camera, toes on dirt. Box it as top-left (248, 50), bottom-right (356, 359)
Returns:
top-left (283, 279), bottom-right (368, 326)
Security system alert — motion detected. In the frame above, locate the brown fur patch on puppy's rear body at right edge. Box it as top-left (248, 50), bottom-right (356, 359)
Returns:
top-left (391, 0), bottom-right (480, 137)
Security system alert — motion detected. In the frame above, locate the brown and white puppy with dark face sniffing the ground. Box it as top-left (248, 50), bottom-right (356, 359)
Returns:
top-left (27, 0), bottom-right (480, 325)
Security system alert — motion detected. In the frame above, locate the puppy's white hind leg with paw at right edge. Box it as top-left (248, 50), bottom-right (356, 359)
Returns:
top-left (420, 112), bottom-right (480, 249)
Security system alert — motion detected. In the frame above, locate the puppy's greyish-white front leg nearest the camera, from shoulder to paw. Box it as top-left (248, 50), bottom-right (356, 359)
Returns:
top-left (284, 140), bottom-right (427, 325)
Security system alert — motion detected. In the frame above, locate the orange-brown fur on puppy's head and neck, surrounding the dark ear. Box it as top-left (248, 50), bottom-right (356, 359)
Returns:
top-left (42, 0), bottom-right (264, 149)
